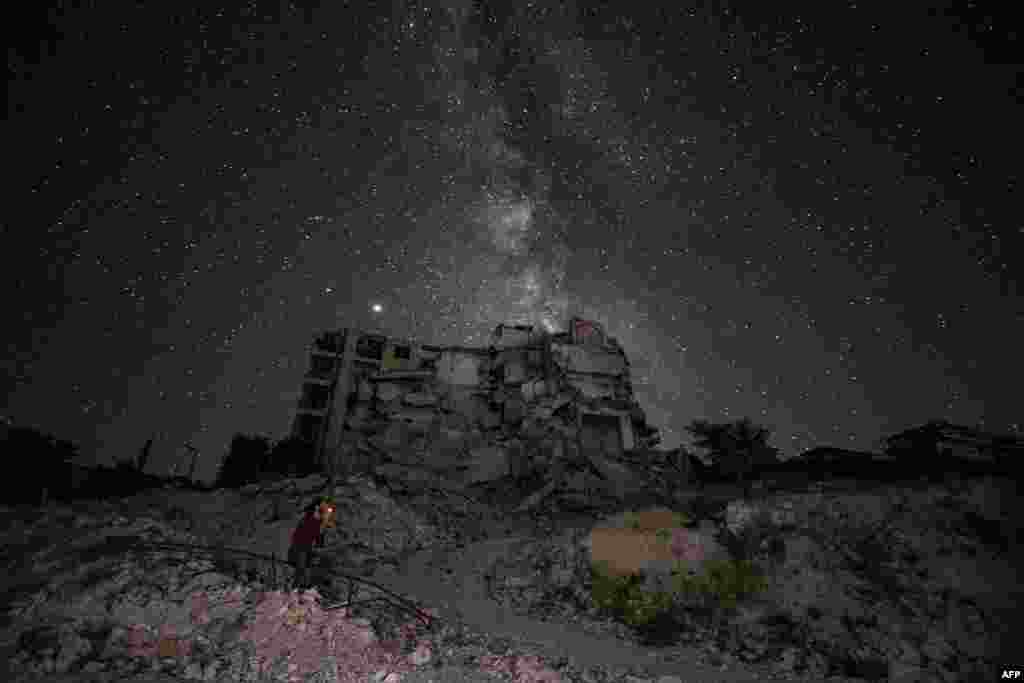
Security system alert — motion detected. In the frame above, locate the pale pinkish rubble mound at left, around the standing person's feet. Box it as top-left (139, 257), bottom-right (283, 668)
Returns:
top-left (0, 479), bottom-right (468, 683)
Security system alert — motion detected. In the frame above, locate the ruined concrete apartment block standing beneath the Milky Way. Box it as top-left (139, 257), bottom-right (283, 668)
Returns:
top-left (291, 318), bottom-right (659, 479)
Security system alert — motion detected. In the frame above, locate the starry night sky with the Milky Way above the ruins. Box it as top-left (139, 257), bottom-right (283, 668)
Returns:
top-left (2, 0), bottom-right (1024, 478)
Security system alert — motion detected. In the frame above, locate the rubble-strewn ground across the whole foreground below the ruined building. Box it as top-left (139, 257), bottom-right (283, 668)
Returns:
top-left (2, 462), bottom-right (1024, 683)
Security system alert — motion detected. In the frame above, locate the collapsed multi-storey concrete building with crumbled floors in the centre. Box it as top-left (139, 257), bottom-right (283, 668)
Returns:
top-left (292, 318), bottom-right (659, 502)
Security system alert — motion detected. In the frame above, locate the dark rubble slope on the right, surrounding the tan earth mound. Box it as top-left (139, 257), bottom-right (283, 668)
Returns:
top-left (488, 480), bottom-right (1024, 681)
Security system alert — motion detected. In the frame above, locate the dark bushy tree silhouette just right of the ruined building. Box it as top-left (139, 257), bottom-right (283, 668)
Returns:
top-left (685, 418), bottom-right (777, 498)
